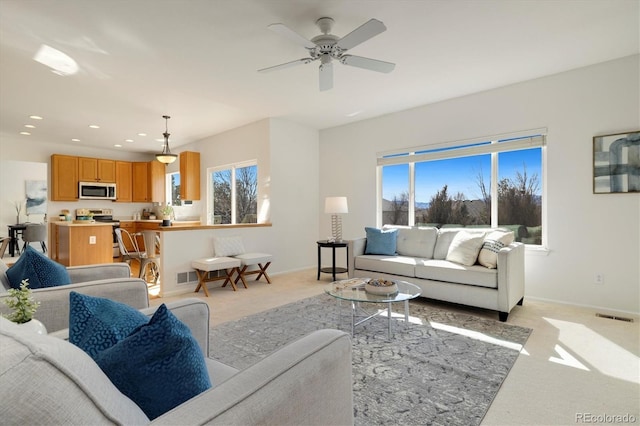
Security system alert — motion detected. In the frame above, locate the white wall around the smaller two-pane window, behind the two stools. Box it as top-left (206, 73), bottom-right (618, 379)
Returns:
top-left (161, 119), bottom-right (319, 296)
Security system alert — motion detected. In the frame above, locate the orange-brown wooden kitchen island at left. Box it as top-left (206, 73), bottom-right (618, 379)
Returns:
top-left (49, 221), bottom-right (113, 266)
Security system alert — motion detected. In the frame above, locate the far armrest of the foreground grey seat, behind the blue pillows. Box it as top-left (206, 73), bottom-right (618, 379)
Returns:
top-left (141, 298), bottom-right (209, 357)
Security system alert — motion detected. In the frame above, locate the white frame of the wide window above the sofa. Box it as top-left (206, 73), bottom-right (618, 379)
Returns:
top-left (376, 128), bottom-right (548, 250)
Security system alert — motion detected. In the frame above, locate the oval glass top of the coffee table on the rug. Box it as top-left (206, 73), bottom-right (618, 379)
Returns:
top-left (324, 278), bottom-right (422, 303)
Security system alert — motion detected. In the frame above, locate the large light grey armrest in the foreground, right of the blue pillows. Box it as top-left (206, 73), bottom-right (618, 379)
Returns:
top-left (151, 330), bottom-right (353, 425)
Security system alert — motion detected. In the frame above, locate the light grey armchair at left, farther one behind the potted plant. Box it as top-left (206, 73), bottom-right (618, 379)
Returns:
top-left (0, 260), bottom-right (149, 333)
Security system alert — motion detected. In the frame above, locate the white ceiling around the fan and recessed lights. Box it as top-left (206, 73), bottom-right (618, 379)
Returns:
top-left (0, 0), bottom-right (640, 152)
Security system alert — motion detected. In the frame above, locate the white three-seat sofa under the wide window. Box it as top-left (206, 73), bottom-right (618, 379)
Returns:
top-left (348, 225), bottom-right (524, 321)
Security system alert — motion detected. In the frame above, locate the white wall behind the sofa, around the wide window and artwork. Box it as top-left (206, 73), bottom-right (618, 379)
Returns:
top-left (318, 56), bottom-right (640, 313)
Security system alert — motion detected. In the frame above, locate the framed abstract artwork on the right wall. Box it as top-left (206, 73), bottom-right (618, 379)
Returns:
top-left (593, 130), bottom-right (640, 194)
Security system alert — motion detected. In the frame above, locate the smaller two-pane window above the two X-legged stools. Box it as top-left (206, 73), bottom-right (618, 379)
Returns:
top-left (207, 161), bottom-right (258, 225)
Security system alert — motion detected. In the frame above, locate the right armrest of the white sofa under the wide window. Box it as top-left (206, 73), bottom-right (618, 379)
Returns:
top-left (498, 242), bottom-right (524, 313)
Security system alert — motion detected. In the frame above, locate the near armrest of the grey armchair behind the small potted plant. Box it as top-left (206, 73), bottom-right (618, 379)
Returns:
top-left (0, 278), bottom-right (149, 332)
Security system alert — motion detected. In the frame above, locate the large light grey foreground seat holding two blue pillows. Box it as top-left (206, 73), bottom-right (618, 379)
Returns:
top-left (0, 299), bottom-right (353, 425)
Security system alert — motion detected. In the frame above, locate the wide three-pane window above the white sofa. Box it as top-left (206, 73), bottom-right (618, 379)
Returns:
top-left (378, 130), bottom-right (546, 245)
